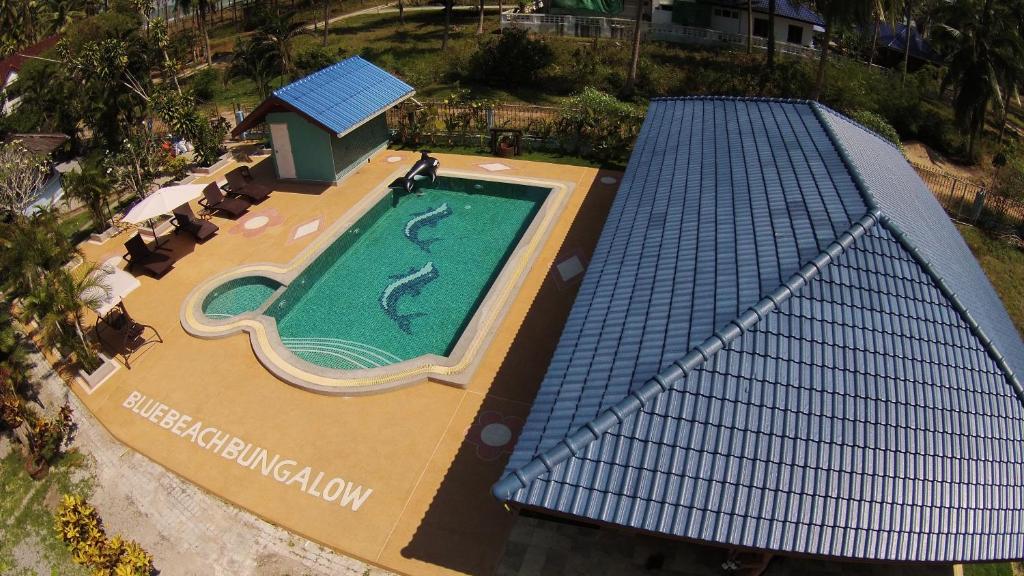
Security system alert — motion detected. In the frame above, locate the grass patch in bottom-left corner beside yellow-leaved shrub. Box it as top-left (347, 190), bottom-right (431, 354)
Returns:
top-left (0, 451), bottom-right (91, 576)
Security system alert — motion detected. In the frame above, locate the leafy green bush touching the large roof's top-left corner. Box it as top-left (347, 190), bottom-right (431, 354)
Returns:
top-left (556, 88), bottom-right (644, 161)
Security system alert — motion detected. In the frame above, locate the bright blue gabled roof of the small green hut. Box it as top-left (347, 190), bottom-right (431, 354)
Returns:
top-left (232, 56), bottom-right (415, 137)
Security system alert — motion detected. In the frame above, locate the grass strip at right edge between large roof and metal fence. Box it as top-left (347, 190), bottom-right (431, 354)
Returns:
top-left (957, 225), bottom-right (1024, 334)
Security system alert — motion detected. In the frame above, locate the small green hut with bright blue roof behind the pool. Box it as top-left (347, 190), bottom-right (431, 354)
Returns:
top-left (231, 56), bottom-right (415, 183)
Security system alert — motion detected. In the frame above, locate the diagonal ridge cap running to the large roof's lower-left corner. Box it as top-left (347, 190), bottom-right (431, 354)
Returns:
top-left (492, 208), bottom-right (880, 501)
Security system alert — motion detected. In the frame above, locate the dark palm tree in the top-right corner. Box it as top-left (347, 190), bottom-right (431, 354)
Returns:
top-left (936, 0), bottom-right (1024, 158)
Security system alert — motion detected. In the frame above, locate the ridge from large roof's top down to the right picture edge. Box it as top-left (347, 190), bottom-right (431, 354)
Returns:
top-left (811, 102), bottom-right (1024, 403)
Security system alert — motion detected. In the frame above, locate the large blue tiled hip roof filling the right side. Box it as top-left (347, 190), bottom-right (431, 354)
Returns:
top-left (494, 98), bottom-right (1024, 562)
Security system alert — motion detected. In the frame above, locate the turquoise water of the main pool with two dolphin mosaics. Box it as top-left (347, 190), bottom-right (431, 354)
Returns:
top-left (265, 177), bottom-right (551, 369)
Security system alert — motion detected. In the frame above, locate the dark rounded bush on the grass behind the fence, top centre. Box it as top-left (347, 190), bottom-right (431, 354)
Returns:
top-left (470, 28), bottom-right (555, 87)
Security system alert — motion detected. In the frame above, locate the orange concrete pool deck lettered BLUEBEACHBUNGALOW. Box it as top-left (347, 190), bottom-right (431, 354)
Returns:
top-left (75, 151), bottom-right (621, 574)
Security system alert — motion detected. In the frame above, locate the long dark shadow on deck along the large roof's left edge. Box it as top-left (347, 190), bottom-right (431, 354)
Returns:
top-left (401, 171), bottom-right (622, 574)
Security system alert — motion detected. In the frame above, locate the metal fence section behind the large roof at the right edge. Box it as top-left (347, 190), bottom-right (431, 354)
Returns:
top-left (913, 164), bottom-right (1024, 229)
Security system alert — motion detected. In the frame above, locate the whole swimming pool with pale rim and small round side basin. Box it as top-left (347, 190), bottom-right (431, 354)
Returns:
top-left (182, 172), bottom-right (566, 392)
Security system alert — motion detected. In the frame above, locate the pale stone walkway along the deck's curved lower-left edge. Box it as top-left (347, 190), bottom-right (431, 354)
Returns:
top-left (32, 344), bottom-right (389, 576)
